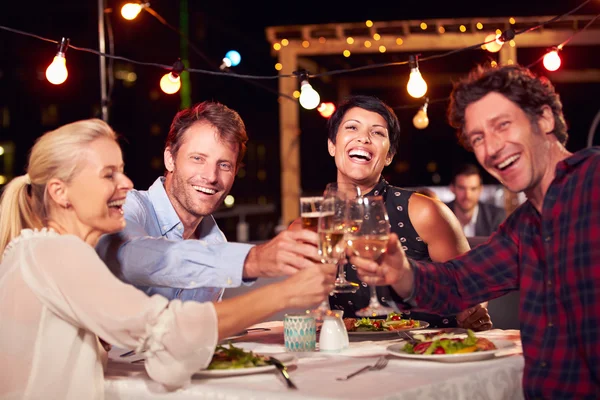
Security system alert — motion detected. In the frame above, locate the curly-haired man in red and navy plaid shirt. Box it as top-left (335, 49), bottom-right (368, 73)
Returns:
top-left (351, 65), bottom-right (600, 399)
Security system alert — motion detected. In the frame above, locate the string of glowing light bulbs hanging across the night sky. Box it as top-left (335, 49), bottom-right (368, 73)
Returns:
top-left (0, 0), bottom-right (600, 129)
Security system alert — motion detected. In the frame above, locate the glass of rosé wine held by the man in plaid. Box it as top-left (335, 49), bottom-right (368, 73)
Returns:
top-left (346, 196), bottom-right (394, 317)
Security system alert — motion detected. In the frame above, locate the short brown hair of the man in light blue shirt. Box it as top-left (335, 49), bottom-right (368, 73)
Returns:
top-left (165, 101), bottom-right (248, 167)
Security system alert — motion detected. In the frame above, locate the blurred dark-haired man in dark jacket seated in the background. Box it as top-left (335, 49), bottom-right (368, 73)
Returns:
top-left (447, 164), bottom-right (506, 237)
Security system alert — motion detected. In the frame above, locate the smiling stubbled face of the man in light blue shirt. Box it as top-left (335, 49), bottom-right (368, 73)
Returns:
top-left (164, 122), bottom-right (239, 228)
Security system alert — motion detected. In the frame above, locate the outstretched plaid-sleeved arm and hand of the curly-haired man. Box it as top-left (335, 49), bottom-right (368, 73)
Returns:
top-left (350, 223), bottom-right (519, 314)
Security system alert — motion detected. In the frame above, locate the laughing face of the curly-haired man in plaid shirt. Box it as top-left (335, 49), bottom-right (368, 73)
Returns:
top-left (465, 92), bottom-right (555, 194)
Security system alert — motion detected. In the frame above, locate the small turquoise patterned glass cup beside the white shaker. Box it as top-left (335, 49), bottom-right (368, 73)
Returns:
top-left (283, 314), bottom-right (317, 352)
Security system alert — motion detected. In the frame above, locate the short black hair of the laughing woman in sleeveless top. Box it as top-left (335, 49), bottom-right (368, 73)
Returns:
top-left (327, 95), bottom-right (400, 156)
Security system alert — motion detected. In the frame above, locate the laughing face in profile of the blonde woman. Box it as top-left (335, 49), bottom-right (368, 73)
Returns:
top-left (66, 138), bottom-right (133, 234)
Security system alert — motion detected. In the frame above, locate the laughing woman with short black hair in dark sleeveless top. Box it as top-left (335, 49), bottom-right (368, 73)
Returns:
top-left (327, 95), bottom-right (492, 330)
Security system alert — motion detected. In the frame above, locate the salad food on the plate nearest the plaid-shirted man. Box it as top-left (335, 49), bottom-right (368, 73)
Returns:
top-left (403, 329), bottom-right (496, 355)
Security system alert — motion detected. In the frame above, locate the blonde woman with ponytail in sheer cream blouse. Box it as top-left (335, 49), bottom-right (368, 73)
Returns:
top-left (0, 119), bottom-right (335, 399)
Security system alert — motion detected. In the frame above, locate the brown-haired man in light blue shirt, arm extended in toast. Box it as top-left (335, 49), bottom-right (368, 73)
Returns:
top-left (96, 102), bottom-right (319, 302)
